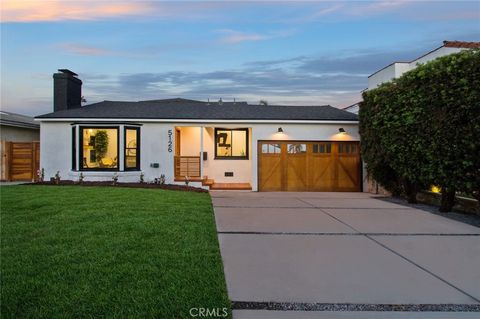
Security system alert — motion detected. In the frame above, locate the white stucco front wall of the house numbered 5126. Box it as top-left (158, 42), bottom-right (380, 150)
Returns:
top-left (40, 122), bottom-right (360, 191)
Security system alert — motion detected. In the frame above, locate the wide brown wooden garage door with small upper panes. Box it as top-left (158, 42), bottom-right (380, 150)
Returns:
top-left (258, 141), bottom-right (361, 192)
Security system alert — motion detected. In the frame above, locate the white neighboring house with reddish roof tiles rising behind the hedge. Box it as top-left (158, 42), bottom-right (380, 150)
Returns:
top-left (370, 41), bottom-right (480, 90)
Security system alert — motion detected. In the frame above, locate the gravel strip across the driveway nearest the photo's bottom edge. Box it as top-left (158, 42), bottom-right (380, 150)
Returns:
top-left (232, 301), bottom-right (480, 312)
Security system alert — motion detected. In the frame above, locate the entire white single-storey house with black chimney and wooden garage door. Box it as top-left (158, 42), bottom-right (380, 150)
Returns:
top-left (37, 70), bottom-right (362, 191)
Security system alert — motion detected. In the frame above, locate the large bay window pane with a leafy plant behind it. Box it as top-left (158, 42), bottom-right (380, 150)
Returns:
top-left (79, 126), bottom-right (120, 171)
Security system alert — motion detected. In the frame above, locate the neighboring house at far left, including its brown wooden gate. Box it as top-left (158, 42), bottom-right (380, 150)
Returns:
top-left (0, 111), bottom-right (40, 181)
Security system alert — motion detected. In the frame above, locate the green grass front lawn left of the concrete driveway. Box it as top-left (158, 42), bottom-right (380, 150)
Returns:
top-left (0, 186), bottom-right (230, 318)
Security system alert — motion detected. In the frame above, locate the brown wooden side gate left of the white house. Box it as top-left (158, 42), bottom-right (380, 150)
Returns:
top-left (0, 141), bottom-right (40, 181)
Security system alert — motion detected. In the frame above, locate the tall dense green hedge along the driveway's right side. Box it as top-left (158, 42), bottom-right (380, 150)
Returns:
top-left (359, 50), bottom-right (480, 211)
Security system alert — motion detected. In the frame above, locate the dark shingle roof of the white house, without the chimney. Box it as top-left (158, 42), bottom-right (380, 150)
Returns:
top-left (37, 99), bottom-right (358, 121)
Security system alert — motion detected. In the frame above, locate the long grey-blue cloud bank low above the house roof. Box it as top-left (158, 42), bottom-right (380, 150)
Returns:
top-left (79, 48), bottom-right (436, 107)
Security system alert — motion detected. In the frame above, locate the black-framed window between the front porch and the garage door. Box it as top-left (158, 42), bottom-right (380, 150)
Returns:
top-left (215, 128), bottom-right (248, 159)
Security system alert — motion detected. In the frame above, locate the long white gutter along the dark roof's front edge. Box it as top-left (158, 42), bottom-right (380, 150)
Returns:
top-left (35, 118), bottom-right (358, 124)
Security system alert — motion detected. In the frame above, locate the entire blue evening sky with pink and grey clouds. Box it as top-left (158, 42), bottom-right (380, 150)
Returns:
top-left (0, 0), bottom-right (480, 116)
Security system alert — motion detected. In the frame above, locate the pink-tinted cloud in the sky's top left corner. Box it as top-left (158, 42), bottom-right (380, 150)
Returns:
top-left (1, 0), bottom-right (150, 22)
